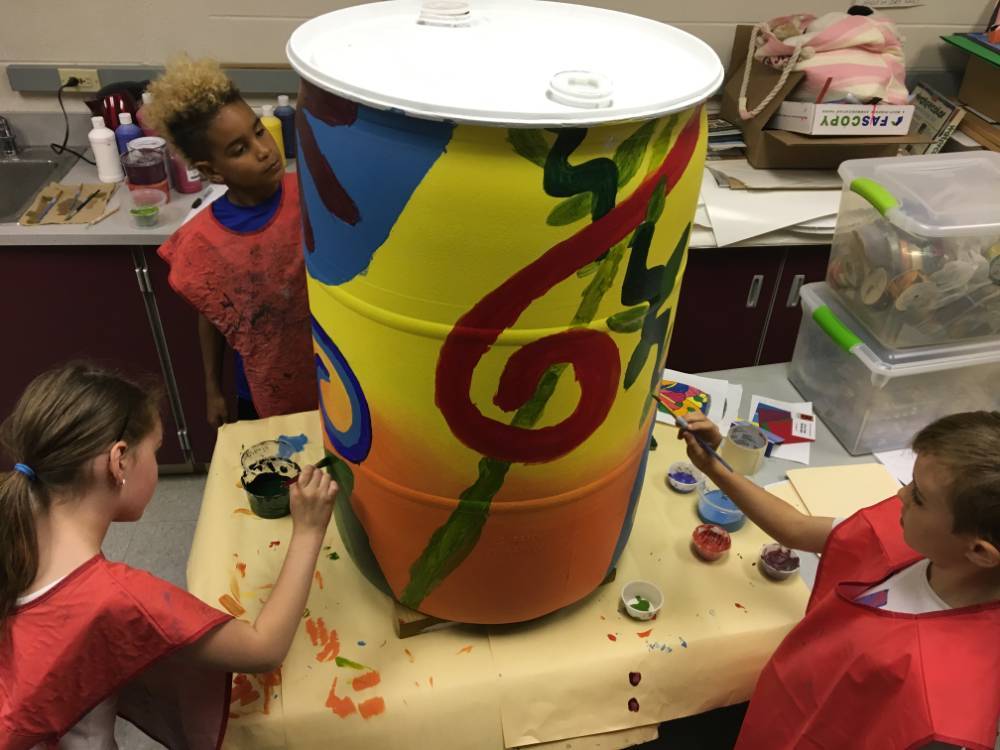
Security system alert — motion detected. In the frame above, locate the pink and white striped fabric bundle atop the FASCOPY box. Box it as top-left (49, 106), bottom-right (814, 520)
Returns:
top-left (754, 13), bottom-right (907, 104)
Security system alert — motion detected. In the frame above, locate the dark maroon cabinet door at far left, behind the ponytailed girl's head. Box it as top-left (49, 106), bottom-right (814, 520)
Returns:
top-left (0, 246), bottom-right (186, 464)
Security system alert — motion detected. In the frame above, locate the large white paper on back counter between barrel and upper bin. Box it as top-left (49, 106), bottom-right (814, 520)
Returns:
top-left (701, 170), bottom-right (840, 247)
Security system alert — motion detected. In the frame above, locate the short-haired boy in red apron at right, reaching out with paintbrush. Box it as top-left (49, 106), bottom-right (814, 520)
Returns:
top-left (681, 412), bottom-right (1000, 750)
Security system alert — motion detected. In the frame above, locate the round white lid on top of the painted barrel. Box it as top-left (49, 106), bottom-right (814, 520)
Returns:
top-left (286, 0), bottom-right (723, 127)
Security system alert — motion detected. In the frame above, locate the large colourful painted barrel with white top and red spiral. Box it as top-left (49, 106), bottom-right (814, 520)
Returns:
top-left (288, 0), bottom-right (722, 623)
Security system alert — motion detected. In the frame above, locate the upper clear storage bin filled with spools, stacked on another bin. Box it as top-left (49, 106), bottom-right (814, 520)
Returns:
top-left (826, 151), bottom-right (1000, 348)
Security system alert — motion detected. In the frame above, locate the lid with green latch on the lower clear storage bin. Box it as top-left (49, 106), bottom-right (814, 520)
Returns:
top-left (799, 280), bottom-right (1000, 384)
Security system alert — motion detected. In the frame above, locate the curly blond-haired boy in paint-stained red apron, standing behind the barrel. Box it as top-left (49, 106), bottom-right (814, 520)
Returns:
top-left (146, 57), bottom-right (318, 426)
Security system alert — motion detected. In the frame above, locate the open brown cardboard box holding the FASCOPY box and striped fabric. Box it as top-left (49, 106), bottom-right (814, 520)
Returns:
top-left (722, 25), bottom-right (930, 169)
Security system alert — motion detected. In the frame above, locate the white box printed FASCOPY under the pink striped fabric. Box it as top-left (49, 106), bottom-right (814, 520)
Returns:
top-left (767, 101), bottom-right (913, 135)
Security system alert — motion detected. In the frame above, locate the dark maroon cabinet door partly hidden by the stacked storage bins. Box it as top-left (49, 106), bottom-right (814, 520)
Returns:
top-left (756, 245), bottom-right (830, 365)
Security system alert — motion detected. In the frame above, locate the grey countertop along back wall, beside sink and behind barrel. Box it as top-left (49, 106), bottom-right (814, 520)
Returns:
top-left (0, 154), bottom-right (830, 249)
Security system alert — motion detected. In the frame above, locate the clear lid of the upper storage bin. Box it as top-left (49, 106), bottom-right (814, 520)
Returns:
top-left (837, 151), bottom-right (1000, 237)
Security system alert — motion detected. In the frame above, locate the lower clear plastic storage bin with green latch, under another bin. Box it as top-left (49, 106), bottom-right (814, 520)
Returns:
top-left (788, 282), bottom-right (1000, 455)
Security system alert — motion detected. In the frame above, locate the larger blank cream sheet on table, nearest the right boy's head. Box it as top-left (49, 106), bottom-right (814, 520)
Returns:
top-left (788, 463), bottom-right (900, 518)
